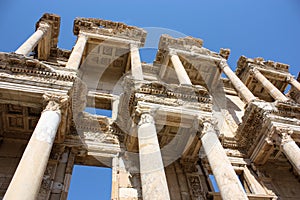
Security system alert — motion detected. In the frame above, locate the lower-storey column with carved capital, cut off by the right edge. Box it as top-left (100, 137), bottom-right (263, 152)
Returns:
top-left (280, 133), bottom-right (300, 175)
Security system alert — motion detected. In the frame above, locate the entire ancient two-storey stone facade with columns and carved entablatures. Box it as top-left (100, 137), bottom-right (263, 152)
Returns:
top-left (0, 14), bottom-right (300, 200)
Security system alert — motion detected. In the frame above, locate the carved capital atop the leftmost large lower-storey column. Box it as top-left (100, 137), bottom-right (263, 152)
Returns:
top-left (43, 93), bottom-right (68, 112)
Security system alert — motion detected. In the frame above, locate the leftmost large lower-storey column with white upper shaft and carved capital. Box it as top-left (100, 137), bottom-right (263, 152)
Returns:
top-left (4, 94), bottom-right (67, 200)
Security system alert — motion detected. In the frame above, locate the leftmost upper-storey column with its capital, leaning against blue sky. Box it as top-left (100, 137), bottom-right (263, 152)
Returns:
top-left (15, 22), bottom-right (50, 56)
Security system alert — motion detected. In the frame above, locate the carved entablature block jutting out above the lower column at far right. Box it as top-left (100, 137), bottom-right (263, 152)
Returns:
top-left (236, 102), bottom-right (300, 164)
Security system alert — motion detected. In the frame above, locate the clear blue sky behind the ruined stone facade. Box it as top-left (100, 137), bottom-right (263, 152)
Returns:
top-left (0, 0), bottom-right (300, 200)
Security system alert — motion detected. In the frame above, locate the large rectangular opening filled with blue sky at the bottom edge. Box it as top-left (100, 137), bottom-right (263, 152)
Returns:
top-left (68, 165), bottom-right (112, 200)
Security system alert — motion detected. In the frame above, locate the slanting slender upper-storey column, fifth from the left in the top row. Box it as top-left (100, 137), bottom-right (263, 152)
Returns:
top-left (219, 60), bottom-right (256, 103)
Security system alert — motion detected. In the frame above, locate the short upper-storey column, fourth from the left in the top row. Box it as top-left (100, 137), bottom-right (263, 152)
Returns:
top-left (170, 53), bottom-right (192, 85)
